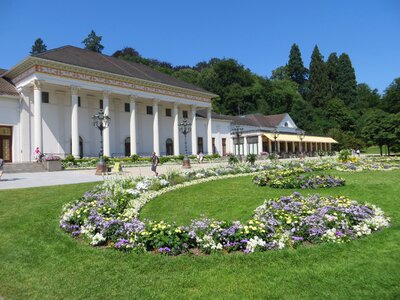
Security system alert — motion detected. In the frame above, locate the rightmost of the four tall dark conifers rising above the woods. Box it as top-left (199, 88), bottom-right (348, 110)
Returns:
top-left (337, 53), bottom-right (357, 105)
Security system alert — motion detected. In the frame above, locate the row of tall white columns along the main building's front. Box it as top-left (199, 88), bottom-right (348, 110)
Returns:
top-left (33, 80), bottom-right (212, 157)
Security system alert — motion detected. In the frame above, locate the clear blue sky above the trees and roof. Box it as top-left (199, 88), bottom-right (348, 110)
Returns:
top-left (0, 0), bottom-right (400, 92)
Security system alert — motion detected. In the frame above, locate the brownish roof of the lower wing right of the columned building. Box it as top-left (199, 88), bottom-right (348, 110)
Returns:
top-left (197, 109), bottom-right (287, 127)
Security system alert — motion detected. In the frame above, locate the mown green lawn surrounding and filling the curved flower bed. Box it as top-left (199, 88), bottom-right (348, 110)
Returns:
top-left (0, 171), bottom-right (400, 299)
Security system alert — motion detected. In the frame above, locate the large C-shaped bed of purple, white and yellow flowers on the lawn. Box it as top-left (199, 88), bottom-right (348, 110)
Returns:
top-left (60, 164), bottom-right (389, 255)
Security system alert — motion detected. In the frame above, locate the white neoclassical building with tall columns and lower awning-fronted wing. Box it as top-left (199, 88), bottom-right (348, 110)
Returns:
top-left (0, 46), bottom-right (335, 162)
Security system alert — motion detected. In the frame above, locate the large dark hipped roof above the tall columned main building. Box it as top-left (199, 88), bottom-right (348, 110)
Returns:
top-left (34, 46), bottom-right (217, 96)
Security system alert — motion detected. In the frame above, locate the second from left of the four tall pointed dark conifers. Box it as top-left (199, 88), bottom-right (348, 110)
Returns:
top-left (309, 46), bottom-right (329, 107)
